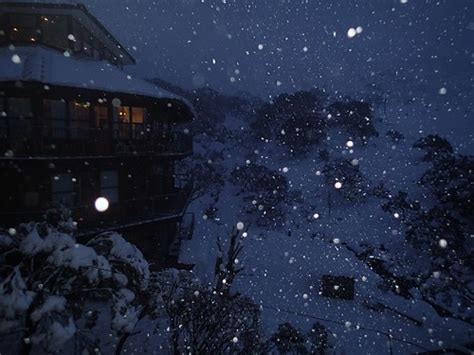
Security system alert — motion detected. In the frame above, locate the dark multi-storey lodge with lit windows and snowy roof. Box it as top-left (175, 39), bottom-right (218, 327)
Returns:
top-left (0, 0), bottom-right (194, 266)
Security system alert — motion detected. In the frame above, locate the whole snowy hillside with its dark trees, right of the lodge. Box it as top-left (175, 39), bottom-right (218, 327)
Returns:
top-left (174, 80), bottom-right (474, 354)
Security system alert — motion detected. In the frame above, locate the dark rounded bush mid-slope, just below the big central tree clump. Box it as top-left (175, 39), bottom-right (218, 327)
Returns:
top-left (230, 164), bottom-right (289, 227)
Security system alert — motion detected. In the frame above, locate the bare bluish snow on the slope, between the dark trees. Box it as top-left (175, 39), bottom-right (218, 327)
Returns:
top-left (181, 96), bottom-right (472, 354)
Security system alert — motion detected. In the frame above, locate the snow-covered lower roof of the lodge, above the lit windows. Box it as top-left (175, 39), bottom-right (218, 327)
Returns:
top-left (0, 45), bottom-right (192, 116)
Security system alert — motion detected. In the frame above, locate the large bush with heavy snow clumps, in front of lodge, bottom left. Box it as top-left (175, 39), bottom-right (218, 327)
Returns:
top-left (0, 221), bottom-right (149, 353)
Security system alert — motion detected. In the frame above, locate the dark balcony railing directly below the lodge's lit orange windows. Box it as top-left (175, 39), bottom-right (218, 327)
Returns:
top-left (0, 118), bottom-right (193, 157)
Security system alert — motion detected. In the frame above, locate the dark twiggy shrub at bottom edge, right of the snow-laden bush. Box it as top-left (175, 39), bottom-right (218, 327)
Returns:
top-left (157, 270), bottom-right (264, 354)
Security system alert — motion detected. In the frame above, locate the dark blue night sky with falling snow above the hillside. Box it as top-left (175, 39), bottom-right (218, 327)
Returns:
top-left (82, 0), bottom-right (474, 96)
